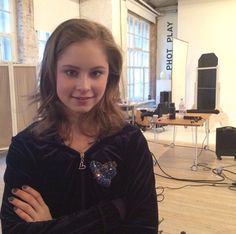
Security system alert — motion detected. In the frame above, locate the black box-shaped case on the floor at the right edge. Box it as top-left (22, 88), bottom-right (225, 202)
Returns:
top-left (216, 126), bottom-right (236, 160)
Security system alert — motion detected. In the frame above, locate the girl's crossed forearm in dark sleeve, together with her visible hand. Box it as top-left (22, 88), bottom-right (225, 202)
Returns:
top-left (1, 183), bottom-right (121, 234)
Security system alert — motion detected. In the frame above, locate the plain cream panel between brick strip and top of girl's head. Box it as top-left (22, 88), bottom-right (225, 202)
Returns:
top-left (34, 0), bottom-right (79, 32)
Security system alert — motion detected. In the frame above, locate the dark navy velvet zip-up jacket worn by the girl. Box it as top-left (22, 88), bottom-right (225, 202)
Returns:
top-left (1, 124), bottom-right (158, 234)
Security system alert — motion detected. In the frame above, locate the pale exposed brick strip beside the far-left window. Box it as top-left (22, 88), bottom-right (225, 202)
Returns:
top-left (16, 0), bottom-right (38, 64)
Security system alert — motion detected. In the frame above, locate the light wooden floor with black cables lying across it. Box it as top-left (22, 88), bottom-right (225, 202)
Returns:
top-left (147, 127), bottom-right (236, 234)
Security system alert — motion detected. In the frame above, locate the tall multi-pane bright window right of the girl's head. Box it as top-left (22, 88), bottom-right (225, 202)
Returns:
top-left (127, 14), bottom-right (150, 101)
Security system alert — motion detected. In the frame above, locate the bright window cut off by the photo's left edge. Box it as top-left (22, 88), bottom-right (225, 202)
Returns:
top-left (0, 0), bottom-right (12, 61)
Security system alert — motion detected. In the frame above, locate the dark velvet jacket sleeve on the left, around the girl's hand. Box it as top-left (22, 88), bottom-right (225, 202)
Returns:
top-left (1, 136), bottom-right (121, 234)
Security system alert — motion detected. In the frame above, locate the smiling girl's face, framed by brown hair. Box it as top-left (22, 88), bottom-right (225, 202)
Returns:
top-left (56, 40), bottom-right (109, 118)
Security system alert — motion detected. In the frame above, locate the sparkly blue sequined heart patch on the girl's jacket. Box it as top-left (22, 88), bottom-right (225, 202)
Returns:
top-left (90, 161), bottom-right (117, 187)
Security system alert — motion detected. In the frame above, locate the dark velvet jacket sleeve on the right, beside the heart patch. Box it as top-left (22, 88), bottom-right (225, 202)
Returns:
top-left (120, 130), bottom-right (158, 234)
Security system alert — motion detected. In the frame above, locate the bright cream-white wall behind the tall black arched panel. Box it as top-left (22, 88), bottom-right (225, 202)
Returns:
top-left (177, 0), bottom-right (236, 126)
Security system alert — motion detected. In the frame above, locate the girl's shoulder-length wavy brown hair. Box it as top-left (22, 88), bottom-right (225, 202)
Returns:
top-left (33, 19), bottom-right (127, 139)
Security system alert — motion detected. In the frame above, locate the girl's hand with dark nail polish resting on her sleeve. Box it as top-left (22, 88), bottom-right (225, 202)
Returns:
top-left (8, 185), bottom-right (52, 222)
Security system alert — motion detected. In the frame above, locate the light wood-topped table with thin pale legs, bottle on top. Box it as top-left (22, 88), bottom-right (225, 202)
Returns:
top-left (155, 113), bottom-right (211, 170)
